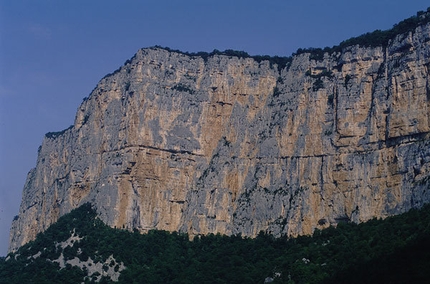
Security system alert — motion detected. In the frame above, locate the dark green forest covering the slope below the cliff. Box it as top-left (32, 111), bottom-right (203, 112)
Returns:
top-left (0, 204), bottom-right (430, 283)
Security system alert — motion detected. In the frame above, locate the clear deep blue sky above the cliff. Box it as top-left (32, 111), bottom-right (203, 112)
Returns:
top-left (0, 0), bottom-right (430, 256)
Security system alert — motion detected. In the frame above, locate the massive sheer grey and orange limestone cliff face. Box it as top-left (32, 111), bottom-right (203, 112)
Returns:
top-left (9, 18), bottom-right (430, 251)
